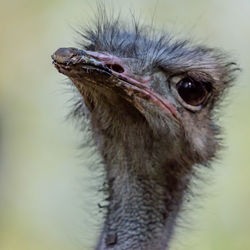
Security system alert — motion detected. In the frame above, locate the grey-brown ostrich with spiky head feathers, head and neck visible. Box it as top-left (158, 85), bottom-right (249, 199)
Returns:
top-left (52, 10), bottom-right (237, 250)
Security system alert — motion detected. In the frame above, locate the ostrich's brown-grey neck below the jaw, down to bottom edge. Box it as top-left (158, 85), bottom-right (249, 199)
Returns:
top-left (92, 101), bottom-right (191, 250)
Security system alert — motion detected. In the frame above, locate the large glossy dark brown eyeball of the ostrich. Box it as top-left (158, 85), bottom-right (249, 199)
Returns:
top-left (176, 78), bottom-right (208, 106)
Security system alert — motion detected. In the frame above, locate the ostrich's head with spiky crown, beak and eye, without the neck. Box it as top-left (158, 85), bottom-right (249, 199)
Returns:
top-left (52, 19), bottom-right (236, 165)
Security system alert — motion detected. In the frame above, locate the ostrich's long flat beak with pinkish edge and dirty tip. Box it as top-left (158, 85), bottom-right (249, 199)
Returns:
top-left (51, 48), bottom-right (177, 118)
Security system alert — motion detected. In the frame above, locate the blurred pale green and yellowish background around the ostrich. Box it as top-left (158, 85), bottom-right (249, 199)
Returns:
top-left (0, 0), bottom-right (250, 250)
